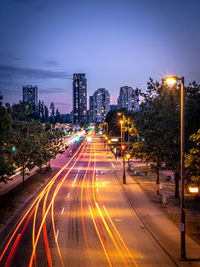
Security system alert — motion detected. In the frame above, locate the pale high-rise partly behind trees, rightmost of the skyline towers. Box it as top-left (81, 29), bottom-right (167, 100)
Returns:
top-left (117, 86), bottom-right (139, 111)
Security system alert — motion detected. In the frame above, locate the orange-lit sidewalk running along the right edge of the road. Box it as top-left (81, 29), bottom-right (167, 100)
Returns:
top-left (109, 155), bottom-right (200, 266)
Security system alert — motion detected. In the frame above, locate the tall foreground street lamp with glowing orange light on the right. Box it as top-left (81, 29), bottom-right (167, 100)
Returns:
top-left (163, 76), bottom-right (186, 260)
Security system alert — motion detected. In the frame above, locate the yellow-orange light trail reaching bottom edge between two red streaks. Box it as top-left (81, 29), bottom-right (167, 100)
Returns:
top-left (29, 144), bottom-right (86, 267)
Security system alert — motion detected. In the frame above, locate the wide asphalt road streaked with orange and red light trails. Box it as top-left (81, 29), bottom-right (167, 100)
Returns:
top-left (0, 137), bottom-right (184, 267)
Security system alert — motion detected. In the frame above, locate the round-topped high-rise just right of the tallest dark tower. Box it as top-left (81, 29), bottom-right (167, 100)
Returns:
top-left (90, 88), bottom-right (110, 123)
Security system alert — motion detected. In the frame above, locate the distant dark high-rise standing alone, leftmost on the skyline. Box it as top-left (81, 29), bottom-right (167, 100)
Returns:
top-left (22, 85), bottom-right (38, 109)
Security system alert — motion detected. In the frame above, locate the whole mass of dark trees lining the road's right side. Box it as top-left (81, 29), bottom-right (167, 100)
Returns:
top-left (106, 79), bottom-right (200, 198)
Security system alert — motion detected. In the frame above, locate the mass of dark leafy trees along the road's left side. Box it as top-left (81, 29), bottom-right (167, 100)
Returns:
top-left (0, 96), bottom-right (63, 184)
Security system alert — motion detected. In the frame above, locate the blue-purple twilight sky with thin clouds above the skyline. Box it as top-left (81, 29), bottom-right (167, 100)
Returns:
top-left (0, 0), bottom-right (200, 113)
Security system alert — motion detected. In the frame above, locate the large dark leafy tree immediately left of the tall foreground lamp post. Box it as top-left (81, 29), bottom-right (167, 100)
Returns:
top-left (134, 79), bottom-right (180, 188)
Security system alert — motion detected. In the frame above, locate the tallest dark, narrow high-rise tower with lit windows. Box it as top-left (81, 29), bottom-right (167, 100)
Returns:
top-left (73, 73), bottom-right (87, 124)
